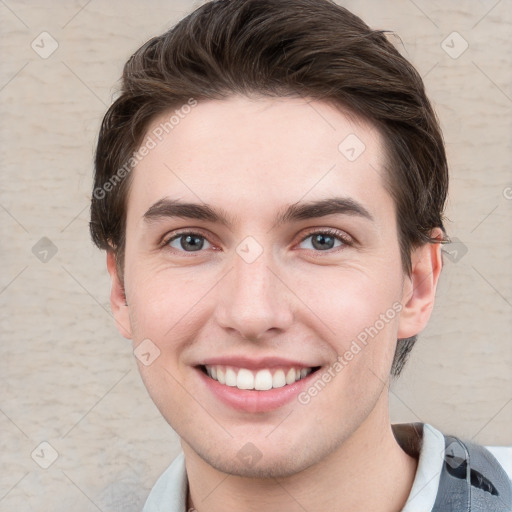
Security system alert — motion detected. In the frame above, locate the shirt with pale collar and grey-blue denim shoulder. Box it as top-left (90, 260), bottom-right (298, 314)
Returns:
top-left (143, 423), bottom-right (512, 512)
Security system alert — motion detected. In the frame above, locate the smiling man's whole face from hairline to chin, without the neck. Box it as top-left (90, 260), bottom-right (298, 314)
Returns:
top-left (112, 97), bottom-right (416, 476)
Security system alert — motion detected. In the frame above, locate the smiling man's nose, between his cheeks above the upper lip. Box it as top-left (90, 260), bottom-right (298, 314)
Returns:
top-left (216, 246), bottom-right (293, 341)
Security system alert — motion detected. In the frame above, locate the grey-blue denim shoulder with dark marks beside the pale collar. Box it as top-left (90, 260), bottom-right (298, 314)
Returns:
top-left (432, 435), bottom-right (512, 512)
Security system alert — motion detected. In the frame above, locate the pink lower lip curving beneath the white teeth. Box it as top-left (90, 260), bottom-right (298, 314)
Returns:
top-left (196, 368), bottom-right (318, 413)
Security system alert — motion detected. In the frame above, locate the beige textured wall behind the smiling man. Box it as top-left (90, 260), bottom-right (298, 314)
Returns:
top-left (0, 0), bottom-right (512, 512)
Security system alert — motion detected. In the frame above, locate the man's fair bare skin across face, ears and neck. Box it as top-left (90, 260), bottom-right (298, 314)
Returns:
top-left (107, 97), bottom-right (441, 512)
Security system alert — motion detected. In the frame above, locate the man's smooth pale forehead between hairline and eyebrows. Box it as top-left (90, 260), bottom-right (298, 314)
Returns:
top-left (128, 96), bottom-right (393, 230)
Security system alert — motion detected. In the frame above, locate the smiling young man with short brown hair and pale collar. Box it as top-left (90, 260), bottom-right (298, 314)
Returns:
top-left (91, 0), bottom-right (512, 512)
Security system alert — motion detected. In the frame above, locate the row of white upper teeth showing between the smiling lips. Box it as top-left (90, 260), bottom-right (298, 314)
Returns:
top-left (199, 365), bottom-right (320, 391)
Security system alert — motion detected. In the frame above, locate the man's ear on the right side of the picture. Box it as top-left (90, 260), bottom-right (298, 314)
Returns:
top-left (398, 228), bottom-right (443, 338)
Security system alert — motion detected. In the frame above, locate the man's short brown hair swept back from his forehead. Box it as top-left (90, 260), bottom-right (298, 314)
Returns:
top-left (90, 0), bottom-right (448, 376)
